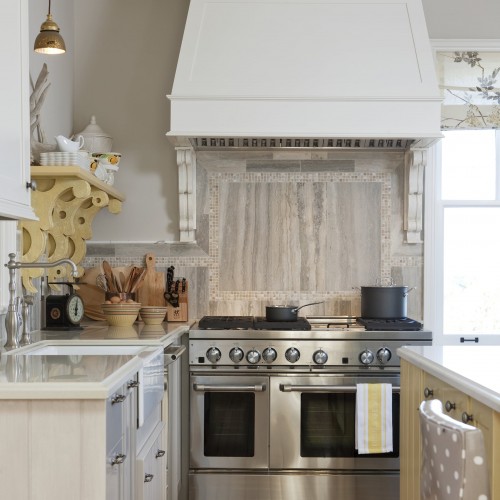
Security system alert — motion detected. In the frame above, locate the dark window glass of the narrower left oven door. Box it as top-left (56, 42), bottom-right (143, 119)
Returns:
top-left (204, 392), bottom-right (255, 457)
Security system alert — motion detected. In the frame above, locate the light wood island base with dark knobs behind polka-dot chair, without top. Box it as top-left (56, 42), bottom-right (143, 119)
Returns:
top-left (400, 360), bottom-right (500, 500)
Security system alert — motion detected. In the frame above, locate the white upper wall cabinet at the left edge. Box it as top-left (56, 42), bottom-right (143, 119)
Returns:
top-left (0, 0), bottom-right (36, 220)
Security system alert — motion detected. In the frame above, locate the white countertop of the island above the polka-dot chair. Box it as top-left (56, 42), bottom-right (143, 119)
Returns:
top-left (397, 346), bottom-right (500, 412)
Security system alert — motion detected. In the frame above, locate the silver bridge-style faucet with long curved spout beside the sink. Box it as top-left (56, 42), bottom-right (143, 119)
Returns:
top-left (5, 253), bottom-right (78, 348)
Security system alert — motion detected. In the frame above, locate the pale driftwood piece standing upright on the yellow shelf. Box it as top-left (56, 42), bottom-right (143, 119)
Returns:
top-left (30, 64), bottom-right (56, 165)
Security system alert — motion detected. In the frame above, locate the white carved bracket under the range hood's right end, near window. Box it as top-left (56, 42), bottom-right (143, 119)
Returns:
top-left (403, 148), bottom-right (427, 244)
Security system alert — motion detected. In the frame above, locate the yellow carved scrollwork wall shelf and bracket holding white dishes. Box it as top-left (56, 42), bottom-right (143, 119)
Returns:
top-left (19, 166), bottom-right (125, 293)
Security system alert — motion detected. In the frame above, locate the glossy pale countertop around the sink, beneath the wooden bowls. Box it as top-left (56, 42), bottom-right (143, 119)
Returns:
top-left (0, 322), bottom-right (190, 400)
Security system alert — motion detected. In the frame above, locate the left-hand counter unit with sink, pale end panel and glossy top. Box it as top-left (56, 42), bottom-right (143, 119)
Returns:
top-left (0, 322), bottom-right (189, 500)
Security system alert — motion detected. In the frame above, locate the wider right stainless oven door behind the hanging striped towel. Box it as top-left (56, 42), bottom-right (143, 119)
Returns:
top-left (270, 375), bottom-right (399, 471)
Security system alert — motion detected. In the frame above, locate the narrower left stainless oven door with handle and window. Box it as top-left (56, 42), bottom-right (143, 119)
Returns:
top-left (190, 374), bottom-right (269, 469)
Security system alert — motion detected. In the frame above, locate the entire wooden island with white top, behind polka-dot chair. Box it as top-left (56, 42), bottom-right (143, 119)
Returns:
top-left (397, 346), bottom-right (500, 500)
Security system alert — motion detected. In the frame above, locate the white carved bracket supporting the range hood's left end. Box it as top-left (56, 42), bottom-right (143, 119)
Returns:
top-left (175, 147), bottom-right (196, 242)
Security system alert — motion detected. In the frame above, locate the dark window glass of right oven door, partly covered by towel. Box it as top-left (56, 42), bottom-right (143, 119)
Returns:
top-left (300, 393), bottom-right (399, 458)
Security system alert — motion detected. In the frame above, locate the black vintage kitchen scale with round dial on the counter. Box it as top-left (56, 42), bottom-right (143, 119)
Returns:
top-left (43, 282), bottom-right (84, 330)
